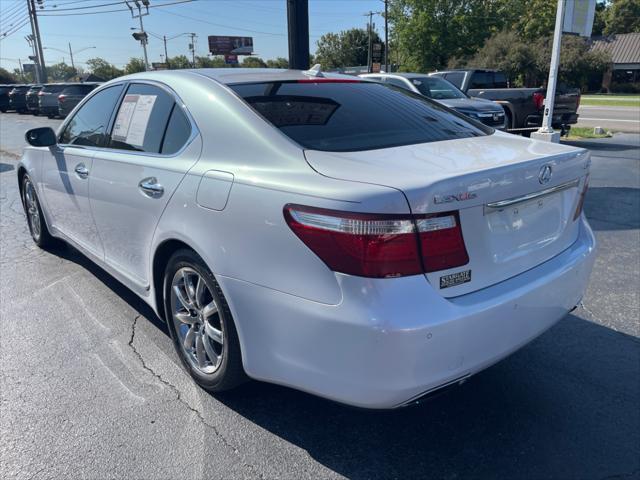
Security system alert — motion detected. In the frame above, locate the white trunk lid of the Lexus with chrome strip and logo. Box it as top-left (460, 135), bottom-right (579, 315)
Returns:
top-left (305, 132), bottom-right (590, 297)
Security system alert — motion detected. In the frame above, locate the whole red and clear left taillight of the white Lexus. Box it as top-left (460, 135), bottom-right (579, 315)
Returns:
top-left (284, 205), bottom-right (469, 278)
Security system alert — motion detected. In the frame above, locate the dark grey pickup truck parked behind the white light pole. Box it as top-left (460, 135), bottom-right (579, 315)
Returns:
top-left (430, 69), bottom-right (580, 135)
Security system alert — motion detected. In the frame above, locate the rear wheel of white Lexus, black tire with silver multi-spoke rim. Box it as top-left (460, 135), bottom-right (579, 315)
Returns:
top-left (163, 249), bottom-right (247, 392)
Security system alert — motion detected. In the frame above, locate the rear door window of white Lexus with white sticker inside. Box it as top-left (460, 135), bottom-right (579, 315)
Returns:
top-left (109, 83), bottom-right (175, 153)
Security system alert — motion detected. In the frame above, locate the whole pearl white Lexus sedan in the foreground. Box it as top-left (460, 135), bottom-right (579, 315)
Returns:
top-left (16, 69), bottom-right (595, 408)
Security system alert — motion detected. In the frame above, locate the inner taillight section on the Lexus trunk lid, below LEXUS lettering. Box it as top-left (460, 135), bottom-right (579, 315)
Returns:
top-left (416, 212), bottom-right (469, 272)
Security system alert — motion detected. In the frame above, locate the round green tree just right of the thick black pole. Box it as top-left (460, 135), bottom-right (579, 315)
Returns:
top-left (316, 28), bottom-right (381, 70)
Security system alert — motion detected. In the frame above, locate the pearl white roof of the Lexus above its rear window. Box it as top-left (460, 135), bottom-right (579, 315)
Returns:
top-left (121, 68), bottom-right (358, 85)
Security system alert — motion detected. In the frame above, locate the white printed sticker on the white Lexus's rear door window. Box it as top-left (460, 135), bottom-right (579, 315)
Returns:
top-left (113, 95), bottom-right (158, 147)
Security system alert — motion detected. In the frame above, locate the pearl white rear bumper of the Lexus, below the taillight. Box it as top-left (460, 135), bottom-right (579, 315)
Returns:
top-left (218, 217), bottom-right (595, 408)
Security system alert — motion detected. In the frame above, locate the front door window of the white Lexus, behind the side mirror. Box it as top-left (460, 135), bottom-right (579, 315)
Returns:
top-left (59, 85), bottom-right (124, 147)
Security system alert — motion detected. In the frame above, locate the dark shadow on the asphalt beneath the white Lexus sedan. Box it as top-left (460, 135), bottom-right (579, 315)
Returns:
top-left (42, 235), bottom-right (640, 479)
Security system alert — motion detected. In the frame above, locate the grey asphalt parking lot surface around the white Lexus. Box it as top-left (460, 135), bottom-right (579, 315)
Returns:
top-left (0, 113), bottom-right (640, 479)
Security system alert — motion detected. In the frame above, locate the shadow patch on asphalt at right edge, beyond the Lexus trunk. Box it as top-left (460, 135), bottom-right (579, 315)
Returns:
top-left (584, 187), bottom-right (640, 230)
